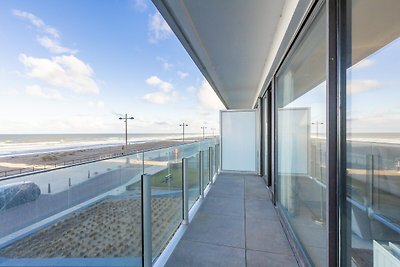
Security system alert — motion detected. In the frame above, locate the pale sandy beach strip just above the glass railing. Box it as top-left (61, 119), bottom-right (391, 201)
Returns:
top-left (0, 140), bottom-right (195, 177)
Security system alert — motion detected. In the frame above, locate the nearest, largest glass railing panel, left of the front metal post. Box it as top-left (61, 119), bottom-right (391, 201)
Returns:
top-left (0, 155), bottom-right (141, 266)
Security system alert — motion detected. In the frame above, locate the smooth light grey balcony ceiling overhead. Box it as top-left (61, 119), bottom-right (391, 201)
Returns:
top-left (153, 0), bottom-right (293, 109)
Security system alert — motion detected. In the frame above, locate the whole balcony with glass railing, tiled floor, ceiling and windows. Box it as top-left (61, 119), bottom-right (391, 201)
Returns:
top-left (0, 0), bottom-right (400, 267)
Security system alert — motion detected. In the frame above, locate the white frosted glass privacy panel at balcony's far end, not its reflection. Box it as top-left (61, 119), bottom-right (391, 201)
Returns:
top-left (221, 110), bottom-right (256, 172)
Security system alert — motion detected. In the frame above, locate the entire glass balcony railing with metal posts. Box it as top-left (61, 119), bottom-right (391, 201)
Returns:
top-left (0, 139), bottom-right (219, 266)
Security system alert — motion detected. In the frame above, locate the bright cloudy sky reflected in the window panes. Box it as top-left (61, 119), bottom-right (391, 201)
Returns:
top-left (286, 38), bottom-right (400, 133)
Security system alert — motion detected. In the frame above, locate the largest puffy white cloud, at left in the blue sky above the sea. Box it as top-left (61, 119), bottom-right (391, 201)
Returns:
top-left (19, 54), bottom-right (100, 94)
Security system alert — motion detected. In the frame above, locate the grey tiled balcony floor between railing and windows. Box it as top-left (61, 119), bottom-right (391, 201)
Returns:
top-left (166, 174), bottom-right (298, 267)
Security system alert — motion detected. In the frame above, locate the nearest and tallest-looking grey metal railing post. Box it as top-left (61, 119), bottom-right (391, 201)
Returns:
top-left (142, 174), bottom-right (153, 267)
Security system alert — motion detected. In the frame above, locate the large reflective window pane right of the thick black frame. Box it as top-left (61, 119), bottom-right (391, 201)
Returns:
top-left (344, 0), bottom-right (400, 266)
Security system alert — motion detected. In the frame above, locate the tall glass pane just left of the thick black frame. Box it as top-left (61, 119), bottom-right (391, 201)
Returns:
top-left (276, 7), bottom-right (327, 266)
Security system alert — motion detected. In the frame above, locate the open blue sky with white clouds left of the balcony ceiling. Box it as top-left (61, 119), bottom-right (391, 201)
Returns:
top-left (0, 0), bottom-right (224, 134)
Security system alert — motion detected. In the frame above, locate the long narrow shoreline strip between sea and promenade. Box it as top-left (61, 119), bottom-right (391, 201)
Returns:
top-left (0, 138), bottom-right (201, 176)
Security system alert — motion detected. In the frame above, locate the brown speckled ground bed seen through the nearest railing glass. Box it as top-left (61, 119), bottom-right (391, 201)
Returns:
top-left (0, 197), bottom-right (181, 258)
